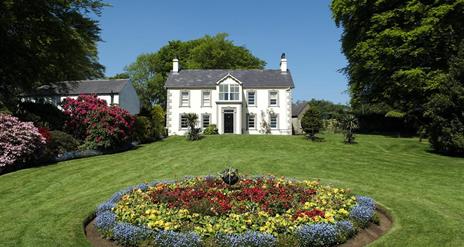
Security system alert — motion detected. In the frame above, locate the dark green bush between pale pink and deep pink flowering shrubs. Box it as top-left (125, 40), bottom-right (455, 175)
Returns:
top-left (41, 130), bottom-right (80, 161)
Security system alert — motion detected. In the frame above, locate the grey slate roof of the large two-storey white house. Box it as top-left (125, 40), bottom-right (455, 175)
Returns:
top-left (166, 69), bottom-right (295, 88)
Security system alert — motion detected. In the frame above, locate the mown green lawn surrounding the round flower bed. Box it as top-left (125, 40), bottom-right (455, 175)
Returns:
top-left (0, 135), bottom-right (464, 246)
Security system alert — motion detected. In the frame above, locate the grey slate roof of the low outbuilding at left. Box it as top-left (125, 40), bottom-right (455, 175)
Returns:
top-left (25, 79), bottom-right (130, 96)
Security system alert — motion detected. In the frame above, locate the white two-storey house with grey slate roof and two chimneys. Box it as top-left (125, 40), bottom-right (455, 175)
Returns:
top-left (166, 54), bottom-right (294, 135)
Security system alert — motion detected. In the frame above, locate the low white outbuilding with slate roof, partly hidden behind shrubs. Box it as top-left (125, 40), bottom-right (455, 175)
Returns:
top-left (21, 79), bottom-right (140, 115)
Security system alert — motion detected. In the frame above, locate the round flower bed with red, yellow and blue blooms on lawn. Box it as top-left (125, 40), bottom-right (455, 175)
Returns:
top-left (95, 177), bottom-right (375, 246)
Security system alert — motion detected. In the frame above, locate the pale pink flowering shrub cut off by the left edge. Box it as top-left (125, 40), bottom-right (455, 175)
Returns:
top-left (0, 114), bottom-right (46, 167)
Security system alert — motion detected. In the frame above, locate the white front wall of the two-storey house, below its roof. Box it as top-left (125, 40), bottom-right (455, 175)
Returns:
top-left (166, 78), bottom-right (293, 135)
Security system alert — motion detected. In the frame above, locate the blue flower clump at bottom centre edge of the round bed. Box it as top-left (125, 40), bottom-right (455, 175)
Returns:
top-left (215, 231), bottom-right (277, 247)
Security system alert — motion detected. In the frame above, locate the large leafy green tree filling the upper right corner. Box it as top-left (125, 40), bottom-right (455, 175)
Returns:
top-left (331, 0), bottom-right (464, 154)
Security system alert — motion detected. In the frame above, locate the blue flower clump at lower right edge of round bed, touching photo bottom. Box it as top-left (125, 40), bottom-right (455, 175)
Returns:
top-left (296, 223), bottom-right (337, 247)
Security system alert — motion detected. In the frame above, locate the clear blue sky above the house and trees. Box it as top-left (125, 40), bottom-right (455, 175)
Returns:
top-left (98, 0), bottom-right (349, 103)
